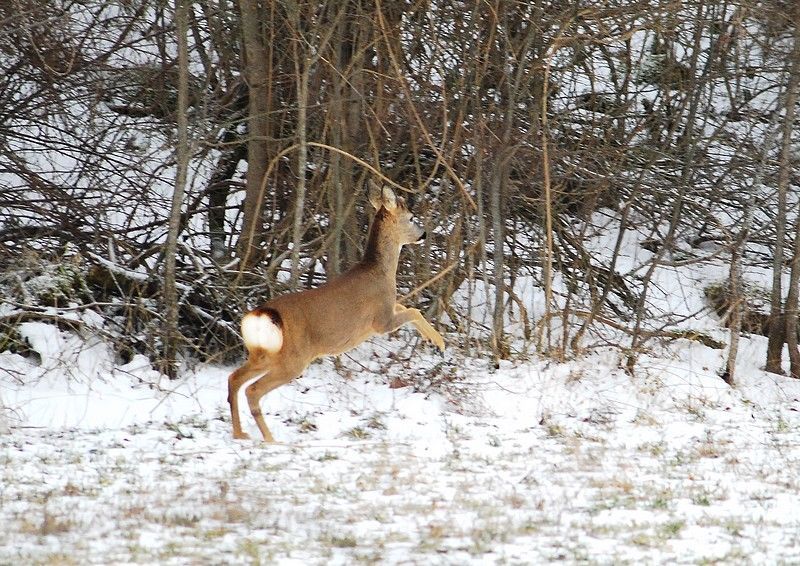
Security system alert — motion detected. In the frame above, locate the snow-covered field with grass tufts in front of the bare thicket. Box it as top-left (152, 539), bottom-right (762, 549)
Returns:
top-left (0, 323), bottom-right (800, 565)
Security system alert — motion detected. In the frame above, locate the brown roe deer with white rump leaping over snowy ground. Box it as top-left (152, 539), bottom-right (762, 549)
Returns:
top-left (228, 183), bottom-right (444, 442)
